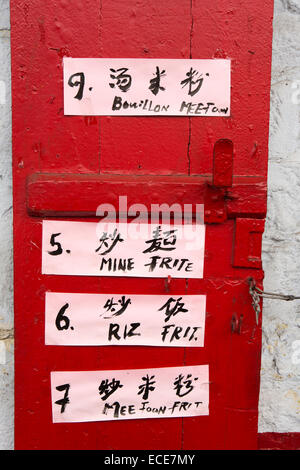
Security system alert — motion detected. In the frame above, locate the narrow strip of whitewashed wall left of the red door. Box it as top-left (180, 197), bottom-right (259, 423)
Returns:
top-left (0, 0), bottom-right (14, 449)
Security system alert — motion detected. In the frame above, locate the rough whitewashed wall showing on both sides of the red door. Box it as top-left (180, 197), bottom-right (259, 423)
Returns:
top-left (0, 0), bottom-right (300, 449)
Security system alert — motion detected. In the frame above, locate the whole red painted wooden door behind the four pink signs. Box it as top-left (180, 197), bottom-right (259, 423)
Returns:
top-left (11, 0), bottom-right (273, 449)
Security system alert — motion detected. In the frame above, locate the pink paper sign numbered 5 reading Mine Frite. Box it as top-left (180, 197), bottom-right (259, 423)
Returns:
top-left (42, 220), bottom-right (205, 278)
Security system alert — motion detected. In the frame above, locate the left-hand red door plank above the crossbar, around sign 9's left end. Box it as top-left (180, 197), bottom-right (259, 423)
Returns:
top-left (11, 0), bottom-right (101, 173)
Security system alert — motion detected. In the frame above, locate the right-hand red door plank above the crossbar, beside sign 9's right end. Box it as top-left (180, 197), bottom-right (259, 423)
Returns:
top-left (190, 0), bottom-right (273, 176)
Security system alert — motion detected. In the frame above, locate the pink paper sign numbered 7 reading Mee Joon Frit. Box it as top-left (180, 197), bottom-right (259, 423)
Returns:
top-left (51, 365), bottom-right (209, 423)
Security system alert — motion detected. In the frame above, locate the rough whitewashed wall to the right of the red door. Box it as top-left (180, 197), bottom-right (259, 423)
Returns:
top-left (260, 0), bottom-right (300, 432)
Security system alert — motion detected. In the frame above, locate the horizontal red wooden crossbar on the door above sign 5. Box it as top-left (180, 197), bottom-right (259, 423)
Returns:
top-left (27, 173), bottom-right (267, 220)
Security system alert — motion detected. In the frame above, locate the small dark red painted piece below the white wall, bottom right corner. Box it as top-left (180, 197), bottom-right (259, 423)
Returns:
top-left (258, 432), bottom-right (300, 450)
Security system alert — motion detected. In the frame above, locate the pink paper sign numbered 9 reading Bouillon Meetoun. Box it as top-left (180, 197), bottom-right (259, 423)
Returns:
top-left (64, 57), bottom-right (230, 117)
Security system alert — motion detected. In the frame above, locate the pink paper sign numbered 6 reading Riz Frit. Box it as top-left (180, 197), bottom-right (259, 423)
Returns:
top-left (46, 292), bottom-right (206, 347)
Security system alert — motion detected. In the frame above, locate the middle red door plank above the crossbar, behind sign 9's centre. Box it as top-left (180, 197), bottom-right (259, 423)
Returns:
top-left (101, 0), bottom-right (191, 175)
